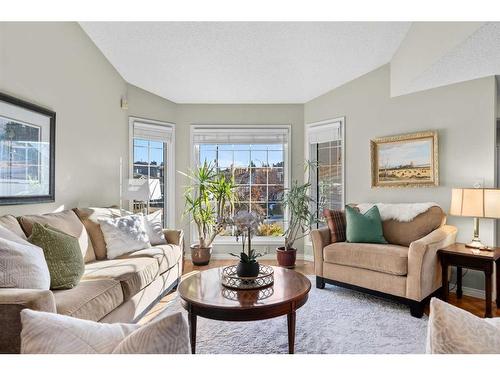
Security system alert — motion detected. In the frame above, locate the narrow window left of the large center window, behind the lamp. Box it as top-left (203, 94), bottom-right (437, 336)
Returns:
top-left (130, 118), bottom-right (175, 226)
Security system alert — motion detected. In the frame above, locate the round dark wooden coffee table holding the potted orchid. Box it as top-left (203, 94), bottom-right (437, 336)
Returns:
top-left (177, 267), bottom-right (311, 354)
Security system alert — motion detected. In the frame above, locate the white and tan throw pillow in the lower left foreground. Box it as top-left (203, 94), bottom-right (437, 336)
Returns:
top-left (21, 309), bottom-right (190, 354)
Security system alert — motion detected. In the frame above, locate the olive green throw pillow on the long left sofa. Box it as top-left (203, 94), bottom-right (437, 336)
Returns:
top-left (28, 223), bottom-right (85, 289)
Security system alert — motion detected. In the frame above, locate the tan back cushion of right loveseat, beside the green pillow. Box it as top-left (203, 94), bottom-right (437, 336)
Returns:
top-left (382, 206), bottom-right (446, 246)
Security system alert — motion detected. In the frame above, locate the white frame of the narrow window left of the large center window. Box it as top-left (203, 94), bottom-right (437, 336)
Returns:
top-left (128, 116), bottom-right (176, 228)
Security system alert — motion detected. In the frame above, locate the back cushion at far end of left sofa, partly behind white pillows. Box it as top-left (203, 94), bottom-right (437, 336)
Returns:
top-left (74, 207), bottom-right (127, 260)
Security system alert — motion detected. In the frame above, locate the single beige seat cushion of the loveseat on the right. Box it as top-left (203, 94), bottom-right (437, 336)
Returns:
top-left (323, 242), bottom-right (408, 276)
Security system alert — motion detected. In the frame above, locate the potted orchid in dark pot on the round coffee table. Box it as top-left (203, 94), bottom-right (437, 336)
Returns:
top-left (231, 211), bottom-right (263, 277)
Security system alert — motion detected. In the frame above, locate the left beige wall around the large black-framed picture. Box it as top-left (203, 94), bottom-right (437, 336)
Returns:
top-left (0, 22), bottom-right (128, 214)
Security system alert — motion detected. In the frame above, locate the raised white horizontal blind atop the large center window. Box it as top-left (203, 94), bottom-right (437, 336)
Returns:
top-left (192, 126), bottom-right (288, 144)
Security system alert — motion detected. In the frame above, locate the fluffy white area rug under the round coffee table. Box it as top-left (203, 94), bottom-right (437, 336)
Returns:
top-left (164, 277), bottom-right (428, 354)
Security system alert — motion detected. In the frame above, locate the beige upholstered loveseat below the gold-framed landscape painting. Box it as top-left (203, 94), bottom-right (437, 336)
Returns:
top-left (311, 206), bottom-right (457, 317)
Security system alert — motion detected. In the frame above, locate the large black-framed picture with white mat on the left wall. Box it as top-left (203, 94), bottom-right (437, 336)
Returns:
top-left (0, 93), bottom-right (56, 205)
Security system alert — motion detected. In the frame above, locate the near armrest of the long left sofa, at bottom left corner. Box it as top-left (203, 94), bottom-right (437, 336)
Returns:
top-left (0, 289), bottom-right (56, 353)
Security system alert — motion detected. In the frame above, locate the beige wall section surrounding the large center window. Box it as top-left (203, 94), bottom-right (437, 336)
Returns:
top-left (175, 104), bottom-right (304, 255)
